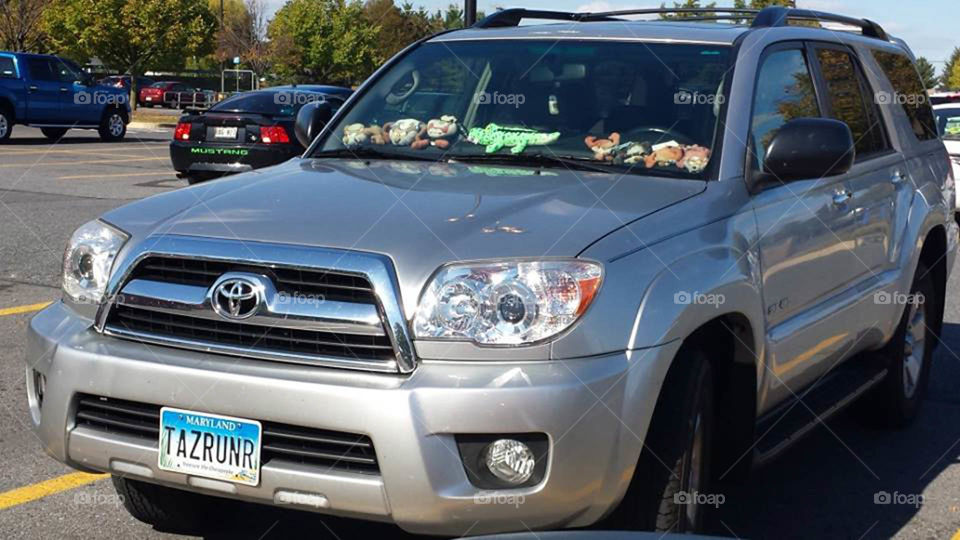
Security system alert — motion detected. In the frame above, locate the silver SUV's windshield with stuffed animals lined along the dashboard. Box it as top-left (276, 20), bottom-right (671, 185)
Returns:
top-left (314, 40), bottom-right (729, 178)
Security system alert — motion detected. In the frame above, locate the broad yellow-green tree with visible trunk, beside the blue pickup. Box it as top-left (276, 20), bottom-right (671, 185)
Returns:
top-left (44, 0), bottom-right (217, 107)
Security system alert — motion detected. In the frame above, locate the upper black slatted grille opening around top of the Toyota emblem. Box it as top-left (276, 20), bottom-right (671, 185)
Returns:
top-left (130, 256), bottom-right (376, 304)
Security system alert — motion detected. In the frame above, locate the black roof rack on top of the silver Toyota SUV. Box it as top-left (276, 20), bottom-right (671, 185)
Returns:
top-left (474, 7), bottom-right (889, 41)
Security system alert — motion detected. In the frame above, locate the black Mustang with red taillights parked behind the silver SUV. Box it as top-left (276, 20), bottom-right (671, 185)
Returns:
top-left (170, 85), bottom-right (352, 184)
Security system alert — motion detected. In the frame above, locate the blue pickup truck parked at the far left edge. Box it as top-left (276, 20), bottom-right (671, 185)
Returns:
top-left (0, 51), bottom-right (130, 143)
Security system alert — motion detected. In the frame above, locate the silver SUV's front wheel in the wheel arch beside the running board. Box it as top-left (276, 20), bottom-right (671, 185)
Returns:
top-left (604, 350), bottom-right (715, 533)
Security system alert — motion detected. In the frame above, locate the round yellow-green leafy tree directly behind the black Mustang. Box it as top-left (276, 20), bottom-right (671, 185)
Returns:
top-left (267, 0), bottom-right (383, 84)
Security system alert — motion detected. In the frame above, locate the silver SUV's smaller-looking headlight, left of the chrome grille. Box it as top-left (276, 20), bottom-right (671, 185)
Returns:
top-left (63, 221), bottom-right (129, 304)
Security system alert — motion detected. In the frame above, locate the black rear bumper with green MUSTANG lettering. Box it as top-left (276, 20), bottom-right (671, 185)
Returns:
top-left (170, 141), bottom-right (303, 173)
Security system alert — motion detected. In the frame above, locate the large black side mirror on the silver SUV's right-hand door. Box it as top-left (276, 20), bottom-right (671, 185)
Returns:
top-left (763, 118), bottom-right (856, 186)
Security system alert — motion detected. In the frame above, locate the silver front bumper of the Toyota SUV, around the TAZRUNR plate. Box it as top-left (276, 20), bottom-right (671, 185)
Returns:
top-left (27, 303), bottom-right (680, 535)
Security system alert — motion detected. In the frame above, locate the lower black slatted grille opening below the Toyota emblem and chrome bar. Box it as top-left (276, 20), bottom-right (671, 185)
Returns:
top-left (110, 305), bottom-right (394, 362)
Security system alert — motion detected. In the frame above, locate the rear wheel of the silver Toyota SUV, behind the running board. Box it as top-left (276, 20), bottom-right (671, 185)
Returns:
top-left (858, 263), bottom-right (938, 428)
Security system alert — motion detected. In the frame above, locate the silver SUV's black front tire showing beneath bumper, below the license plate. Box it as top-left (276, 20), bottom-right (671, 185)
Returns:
top-left (110, 476), bottom-right (229, 530)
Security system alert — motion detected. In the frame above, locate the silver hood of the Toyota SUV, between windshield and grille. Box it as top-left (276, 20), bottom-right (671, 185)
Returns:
top-left (104, 159), bottom-right (706, 304)
